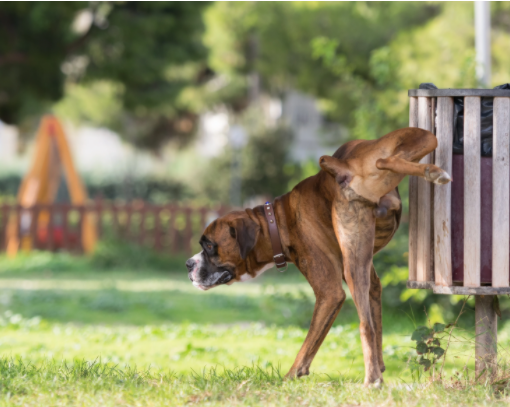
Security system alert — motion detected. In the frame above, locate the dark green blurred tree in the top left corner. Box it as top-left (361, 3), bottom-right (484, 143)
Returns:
top-left (0, 2), bottom-right (207, 147)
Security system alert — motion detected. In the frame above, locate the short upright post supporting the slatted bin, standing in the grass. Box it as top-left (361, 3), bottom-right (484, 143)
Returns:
top-left (475, 295), bottom-right (498, 380)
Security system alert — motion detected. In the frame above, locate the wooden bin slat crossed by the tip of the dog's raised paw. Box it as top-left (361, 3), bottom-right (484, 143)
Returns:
top-left (434, 97), bottom-right (453, 286)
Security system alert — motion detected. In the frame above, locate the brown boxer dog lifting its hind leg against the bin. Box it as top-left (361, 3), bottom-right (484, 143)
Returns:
top-left (186, 128), bottom-right (450, 386)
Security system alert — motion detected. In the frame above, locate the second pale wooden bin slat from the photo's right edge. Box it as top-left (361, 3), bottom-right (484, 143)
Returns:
top-left (464, 96), bottom-right (480, 287)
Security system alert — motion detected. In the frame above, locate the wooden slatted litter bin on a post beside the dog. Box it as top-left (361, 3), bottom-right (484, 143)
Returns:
top-left (407, 89), bottom-right (510, 377)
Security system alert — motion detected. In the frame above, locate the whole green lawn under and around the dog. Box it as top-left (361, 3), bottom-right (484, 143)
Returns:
top-left (0, 253), bottom-right (510, 406)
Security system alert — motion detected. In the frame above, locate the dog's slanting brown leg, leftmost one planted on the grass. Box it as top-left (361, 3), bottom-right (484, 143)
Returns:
top-left (286, 255), bottom-right (346, 378)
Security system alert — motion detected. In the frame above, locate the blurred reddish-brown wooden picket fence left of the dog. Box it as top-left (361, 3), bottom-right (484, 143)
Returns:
top-left (0, 201), bottom-right (228, 255)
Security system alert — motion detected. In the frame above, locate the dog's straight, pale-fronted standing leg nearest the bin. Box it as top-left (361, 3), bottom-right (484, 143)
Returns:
top-left (332, 200), bottom-right (383, 386)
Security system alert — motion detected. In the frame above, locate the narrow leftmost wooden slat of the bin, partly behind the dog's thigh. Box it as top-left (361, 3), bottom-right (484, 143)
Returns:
top-left (408, 97), bottom-right (418, 281)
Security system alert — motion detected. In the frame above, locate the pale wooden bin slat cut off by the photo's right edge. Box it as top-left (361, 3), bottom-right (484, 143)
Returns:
top-left (492, 98), bottom-right (510, 287)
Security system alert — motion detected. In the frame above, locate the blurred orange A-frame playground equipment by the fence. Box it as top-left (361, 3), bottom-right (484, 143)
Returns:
top-left (6, 116), bottom-right (96, 256)
